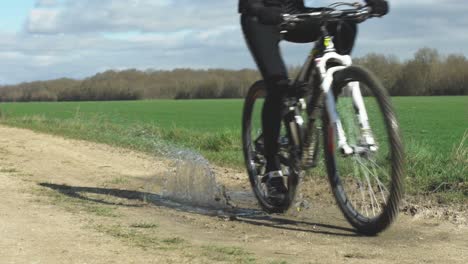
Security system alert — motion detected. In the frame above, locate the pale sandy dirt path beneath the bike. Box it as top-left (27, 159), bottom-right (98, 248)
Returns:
top-left (0, 127), bottom-right (468, 263)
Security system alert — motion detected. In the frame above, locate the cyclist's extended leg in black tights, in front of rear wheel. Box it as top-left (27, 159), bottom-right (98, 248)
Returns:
top-left (241, 15), bottom-right (289, 173)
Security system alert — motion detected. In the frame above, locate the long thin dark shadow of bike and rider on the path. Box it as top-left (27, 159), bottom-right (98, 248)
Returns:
top-left (39, 183), bottom-right (361, 237)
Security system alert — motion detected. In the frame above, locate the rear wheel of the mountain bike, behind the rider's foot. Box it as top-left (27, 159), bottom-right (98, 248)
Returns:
top-left (242, 81), bottom-right (299, 213)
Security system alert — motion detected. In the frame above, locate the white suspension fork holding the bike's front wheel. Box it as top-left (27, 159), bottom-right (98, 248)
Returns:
top-left (315, 41), bottom-right (377, 155)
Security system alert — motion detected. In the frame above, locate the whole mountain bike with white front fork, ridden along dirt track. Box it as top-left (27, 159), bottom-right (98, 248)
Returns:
top-left (242, 3), bottom-right (403, 235)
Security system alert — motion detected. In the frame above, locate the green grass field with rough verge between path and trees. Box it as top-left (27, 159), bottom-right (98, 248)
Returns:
top-left (0, 97), bottom-right (468, 198)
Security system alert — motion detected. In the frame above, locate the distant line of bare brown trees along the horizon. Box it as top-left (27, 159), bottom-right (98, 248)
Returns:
top-left (0, 48), bottom-right (468, 102)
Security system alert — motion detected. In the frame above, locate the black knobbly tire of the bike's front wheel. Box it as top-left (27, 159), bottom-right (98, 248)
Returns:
top-left (323, 66), bottom-right (404, 236)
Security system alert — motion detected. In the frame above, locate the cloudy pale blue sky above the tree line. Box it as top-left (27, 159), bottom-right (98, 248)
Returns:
top-left (0, 0), bottom-right (468, 84)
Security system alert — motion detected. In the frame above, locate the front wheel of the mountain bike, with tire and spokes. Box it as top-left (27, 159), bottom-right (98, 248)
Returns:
top-left (323, 66), bottom-right (403, 235)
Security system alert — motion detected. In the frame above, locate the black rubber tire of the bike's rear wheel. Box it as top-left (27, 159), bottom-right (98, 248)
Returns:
top-left (242, 81), bottom-right (298, 213)
